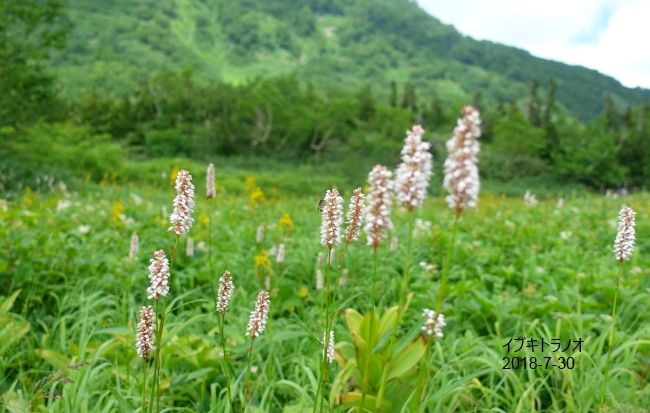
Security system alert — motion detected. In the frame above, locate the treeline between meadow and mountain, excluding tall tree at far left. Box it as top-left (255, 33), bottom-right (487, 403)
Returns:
top-left (2, 73), bottom-right (650, 188)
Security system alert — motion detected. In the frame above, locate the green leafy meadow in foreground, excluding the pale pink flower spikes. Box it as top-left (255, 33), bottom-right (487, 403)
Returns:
top-left (0, 165), bottom-right (650, 412)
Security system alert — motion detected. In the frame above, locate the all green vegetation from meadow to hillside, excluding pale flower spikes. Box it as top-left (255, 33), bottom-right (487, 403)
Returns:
top-left (0, 0), bottom-right (650, 413)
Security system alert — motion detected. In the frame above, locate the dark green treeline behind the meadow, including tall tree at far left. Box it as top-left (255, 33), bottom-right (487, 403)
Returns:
top-left (0, 2), bottom-right (650, 189)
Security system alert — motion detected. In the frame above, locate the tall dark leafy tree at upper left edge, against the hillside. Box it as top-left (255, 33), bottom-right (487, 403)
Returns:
top-left (0, 0), bottom-right (69, 125)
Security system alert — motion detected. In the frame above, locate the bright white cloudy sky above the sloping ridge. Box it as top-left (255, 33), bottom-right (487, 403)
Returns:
top-left (417, 0), bottom-right (650, 89)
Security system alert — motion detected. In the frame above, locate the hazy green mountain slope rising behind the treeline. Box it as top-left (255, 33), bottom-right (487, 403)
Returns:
top-left (53, 0), bottom-right (650, 119)
